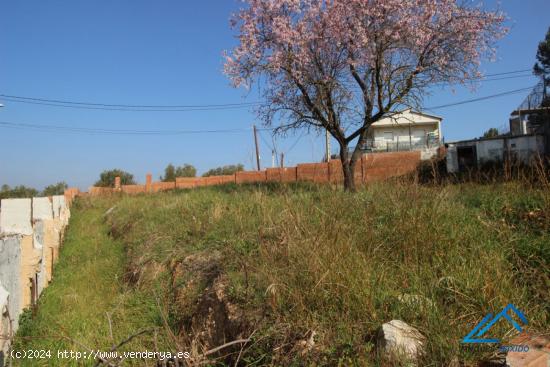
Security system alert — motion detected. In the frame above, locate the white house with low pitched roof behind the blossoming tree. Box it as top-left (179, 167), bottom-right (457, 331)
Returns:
top-left (366, 109), bottom-right (443, 152)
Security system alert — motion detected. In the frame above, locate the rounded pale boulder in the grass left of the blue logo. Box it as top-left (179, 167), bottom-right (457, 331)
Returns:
top-left (377, 320), bottom-right (426, 366)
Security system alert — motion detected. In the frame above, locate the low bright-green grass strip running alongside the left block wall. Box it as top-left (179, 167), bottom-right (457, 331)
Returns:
top-left (14, 200), bottom-right (168, 366)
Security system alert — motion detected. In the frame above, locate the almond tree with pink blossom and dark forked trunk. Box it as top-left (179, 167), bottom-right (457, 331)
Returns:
top-left (225, 0), bottom-right (506, 190)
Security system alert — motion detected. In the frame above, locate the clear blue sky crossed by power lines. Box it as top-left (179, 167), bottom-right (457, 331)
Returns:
top-left (0, 0), bottom-right (550, 189)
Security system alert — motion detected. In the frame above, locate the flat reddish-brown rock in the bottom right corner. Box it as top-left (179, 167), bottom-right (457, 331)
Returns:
top-left (506, 333), bottom-right (550, 367)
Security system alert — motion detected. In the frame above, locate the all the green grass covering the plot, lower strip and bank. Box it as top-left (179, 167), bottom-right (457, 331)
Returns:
top-left (14, 181), bottom-right (550, 366)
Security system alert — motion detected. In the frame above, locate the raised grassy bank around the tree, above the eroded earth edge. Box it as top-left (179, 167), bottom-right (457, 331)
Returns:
top-left (106, 183), bottom-right (550, 366)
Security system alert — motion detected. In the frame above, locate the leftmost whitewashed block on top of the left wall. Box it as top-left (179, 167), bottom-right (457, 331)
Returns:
top-left (0, 199), bottom-right (32, 235)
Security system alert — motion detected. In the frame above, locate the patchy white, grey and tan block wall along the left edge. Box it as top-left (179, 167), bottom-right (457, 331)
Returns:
top-left (0, 196), bottom-right (72, 359)
